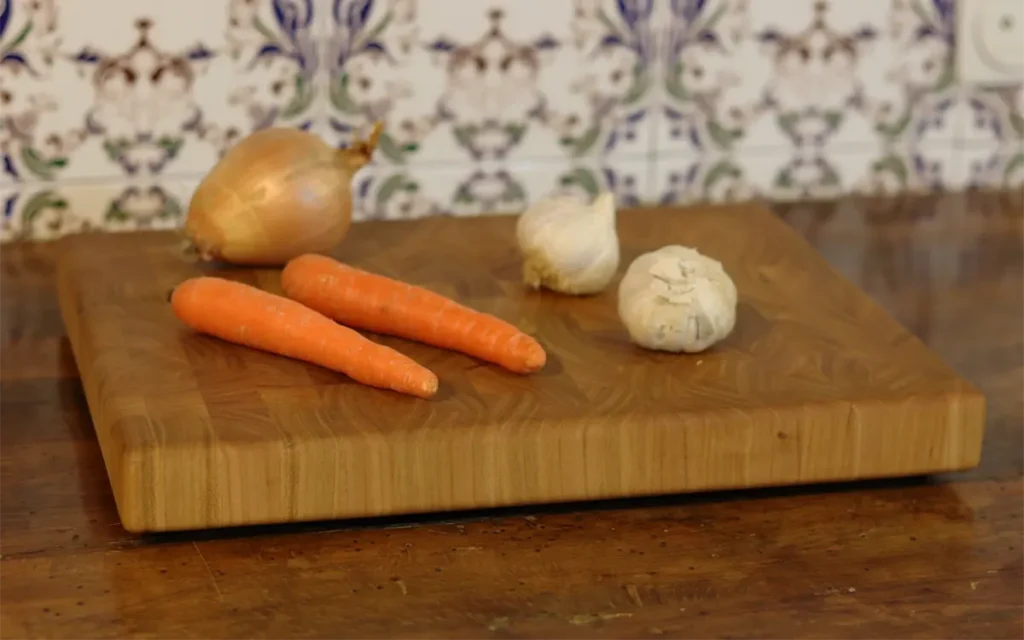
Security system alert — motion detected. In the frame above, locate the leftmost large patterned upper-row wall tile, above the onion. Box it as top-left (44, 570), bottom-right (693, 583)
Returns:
top-left (0, 0), bottom-right (318, 183)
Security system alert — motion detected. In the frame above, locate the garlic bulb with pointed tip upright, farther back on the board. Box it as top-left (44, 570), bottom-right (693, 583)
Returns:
top-left (516, 191), bottom-right (618, 295)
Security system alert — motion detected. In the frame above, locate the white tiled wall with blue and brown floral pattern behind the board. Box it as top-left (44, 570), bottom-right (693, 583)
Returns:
top-left (0, 0), bottom-right (1024, 241)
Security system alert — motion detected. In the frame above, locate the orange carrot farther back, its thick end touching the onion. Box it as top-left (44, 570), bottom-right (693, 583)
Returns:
top-left (281, 254), bottom-right (547, 374)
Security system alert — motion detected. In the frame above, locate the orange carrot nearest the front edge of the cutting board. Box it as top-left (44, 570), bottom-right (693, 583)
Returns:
top-left (171, 276), bottom-right (437, 398)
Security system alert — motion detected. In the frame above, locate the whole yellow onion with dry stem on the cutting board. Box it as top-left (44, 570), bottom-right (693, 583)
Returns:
top-left (184, 122), bottom-right (383, 266)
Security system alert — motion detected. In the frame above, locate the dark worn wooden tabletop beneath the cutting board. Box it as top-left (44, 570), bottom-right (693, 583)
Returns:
top-left (0, 195), bottom-right (1024, 640)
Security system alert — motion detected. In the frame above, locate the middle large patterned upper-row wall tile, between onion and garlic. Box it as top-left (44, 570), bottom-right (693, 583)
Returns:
top-left (323, 0), bottom-right (654, 166)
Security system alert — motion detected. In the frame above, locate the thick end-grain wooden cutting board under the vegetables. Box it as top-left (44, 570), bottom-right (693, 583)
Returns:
top-left (58, 201), bottom-right (985, 531)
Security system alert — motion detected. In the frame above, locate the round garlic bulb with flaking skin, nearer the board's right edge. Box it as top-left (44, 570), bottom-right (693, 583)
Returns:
top-left (618, 245), bottom-right (737, 353)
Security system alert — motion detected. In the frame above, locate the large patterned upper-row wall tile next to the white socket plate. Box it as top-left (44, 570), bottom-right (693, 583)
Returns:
top-left (657, 0), bottom-right (956, 164)
